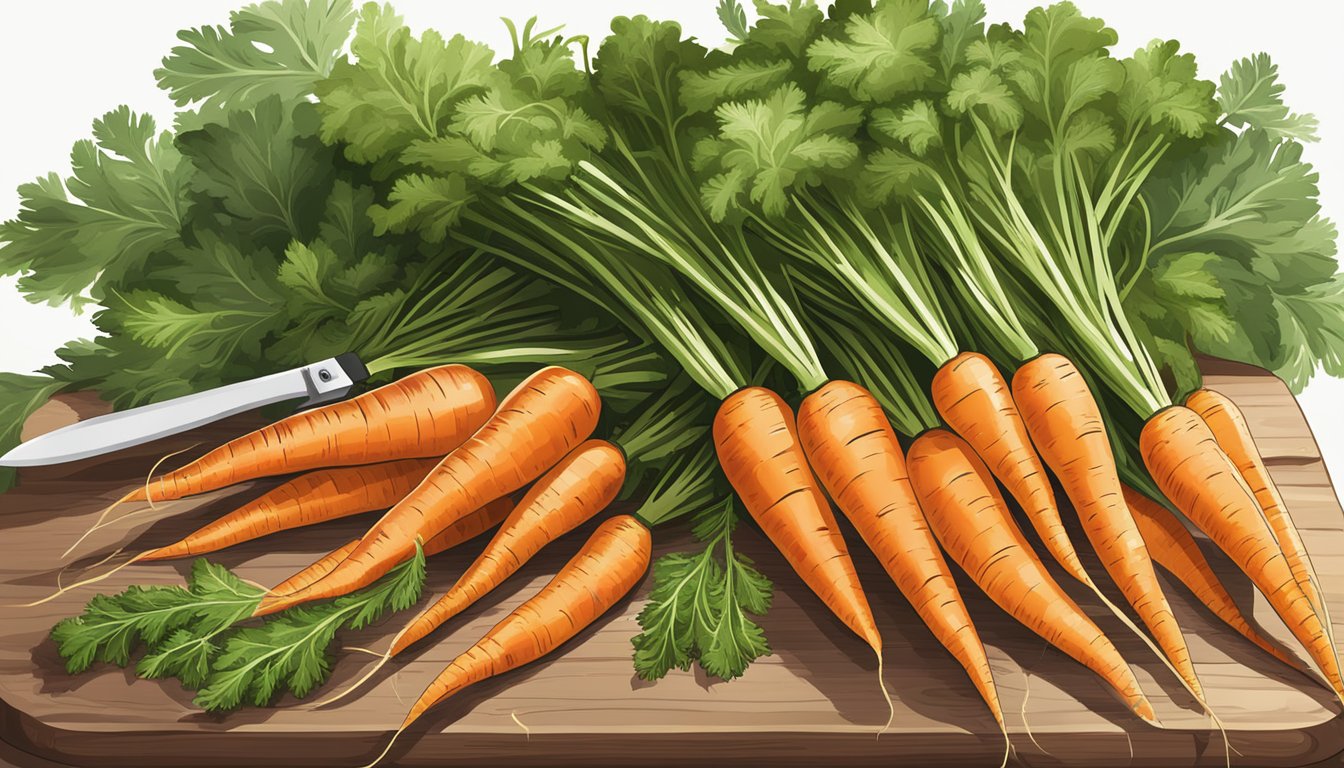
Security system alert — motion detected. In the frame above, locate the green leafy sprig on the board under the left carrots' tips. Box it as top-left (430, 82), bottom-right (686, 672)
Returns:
top-left (51, 547), bottom-right (425, 712)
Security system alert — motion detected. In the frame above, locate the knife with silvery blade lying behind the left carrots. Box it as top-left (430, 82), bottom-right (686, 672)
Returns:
top-left (0, 352), bottom-right (368, 467)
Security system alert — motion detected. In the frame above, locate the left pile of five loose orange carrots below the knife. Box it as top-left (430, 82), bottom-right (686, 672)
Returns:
top-left (46, 364), bottom-right (661, 747)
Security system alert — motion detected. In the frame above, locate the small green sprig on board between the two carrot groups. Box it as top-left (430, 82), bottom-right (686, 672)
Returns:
top-left (632, 502), bottom-right (771, 681)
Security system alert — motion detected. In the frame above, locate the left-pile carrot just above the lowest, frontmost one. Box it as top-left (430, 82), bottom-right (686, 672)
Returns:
top-left (387, 440), bottom-right (625, 658)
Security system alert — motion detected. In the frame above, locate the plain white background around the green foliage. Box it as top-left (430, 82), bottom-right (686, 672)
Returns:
top-left (0, 0), bottom-right (1344, 492)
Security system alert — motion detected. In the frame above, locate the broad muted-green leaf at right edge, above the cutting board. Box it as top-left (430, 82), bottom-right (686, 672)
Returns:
top-left (1126, 128), bottom-right (1344, 391)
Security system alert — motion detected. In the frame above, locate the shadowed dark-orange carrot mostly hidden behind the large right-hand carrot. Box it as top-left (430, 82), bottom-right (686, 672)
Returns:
top-left (1125, 486), bottom-right (1301, 668)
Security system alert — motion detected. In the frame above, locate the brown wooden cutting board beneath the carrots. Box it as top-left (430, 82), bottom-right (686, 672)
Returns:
top-left (0, 362), bottom-right (1344, 767)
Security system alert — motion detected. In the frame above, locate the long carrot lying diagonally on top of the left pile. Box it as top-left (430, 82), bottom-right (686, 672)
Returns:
top-left (255, 366), bottom-right (602, 616)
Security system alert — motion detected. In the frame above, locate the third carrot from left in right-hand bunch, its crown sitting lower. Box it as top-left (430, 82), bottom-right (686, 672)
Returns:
top-left (909, 429), bottom-right (1156, 722)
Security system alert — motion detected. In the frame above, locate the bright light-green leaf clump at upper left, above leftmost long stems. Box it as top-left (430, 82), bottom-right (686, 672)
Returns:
top-left (319, 5), bottom-right (606, 242)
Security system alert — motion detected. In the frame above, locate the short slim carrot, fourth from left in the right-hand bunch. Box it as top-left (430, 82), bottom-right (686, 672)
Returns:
top-left (930, 352), bottom-right (1095, 588)
